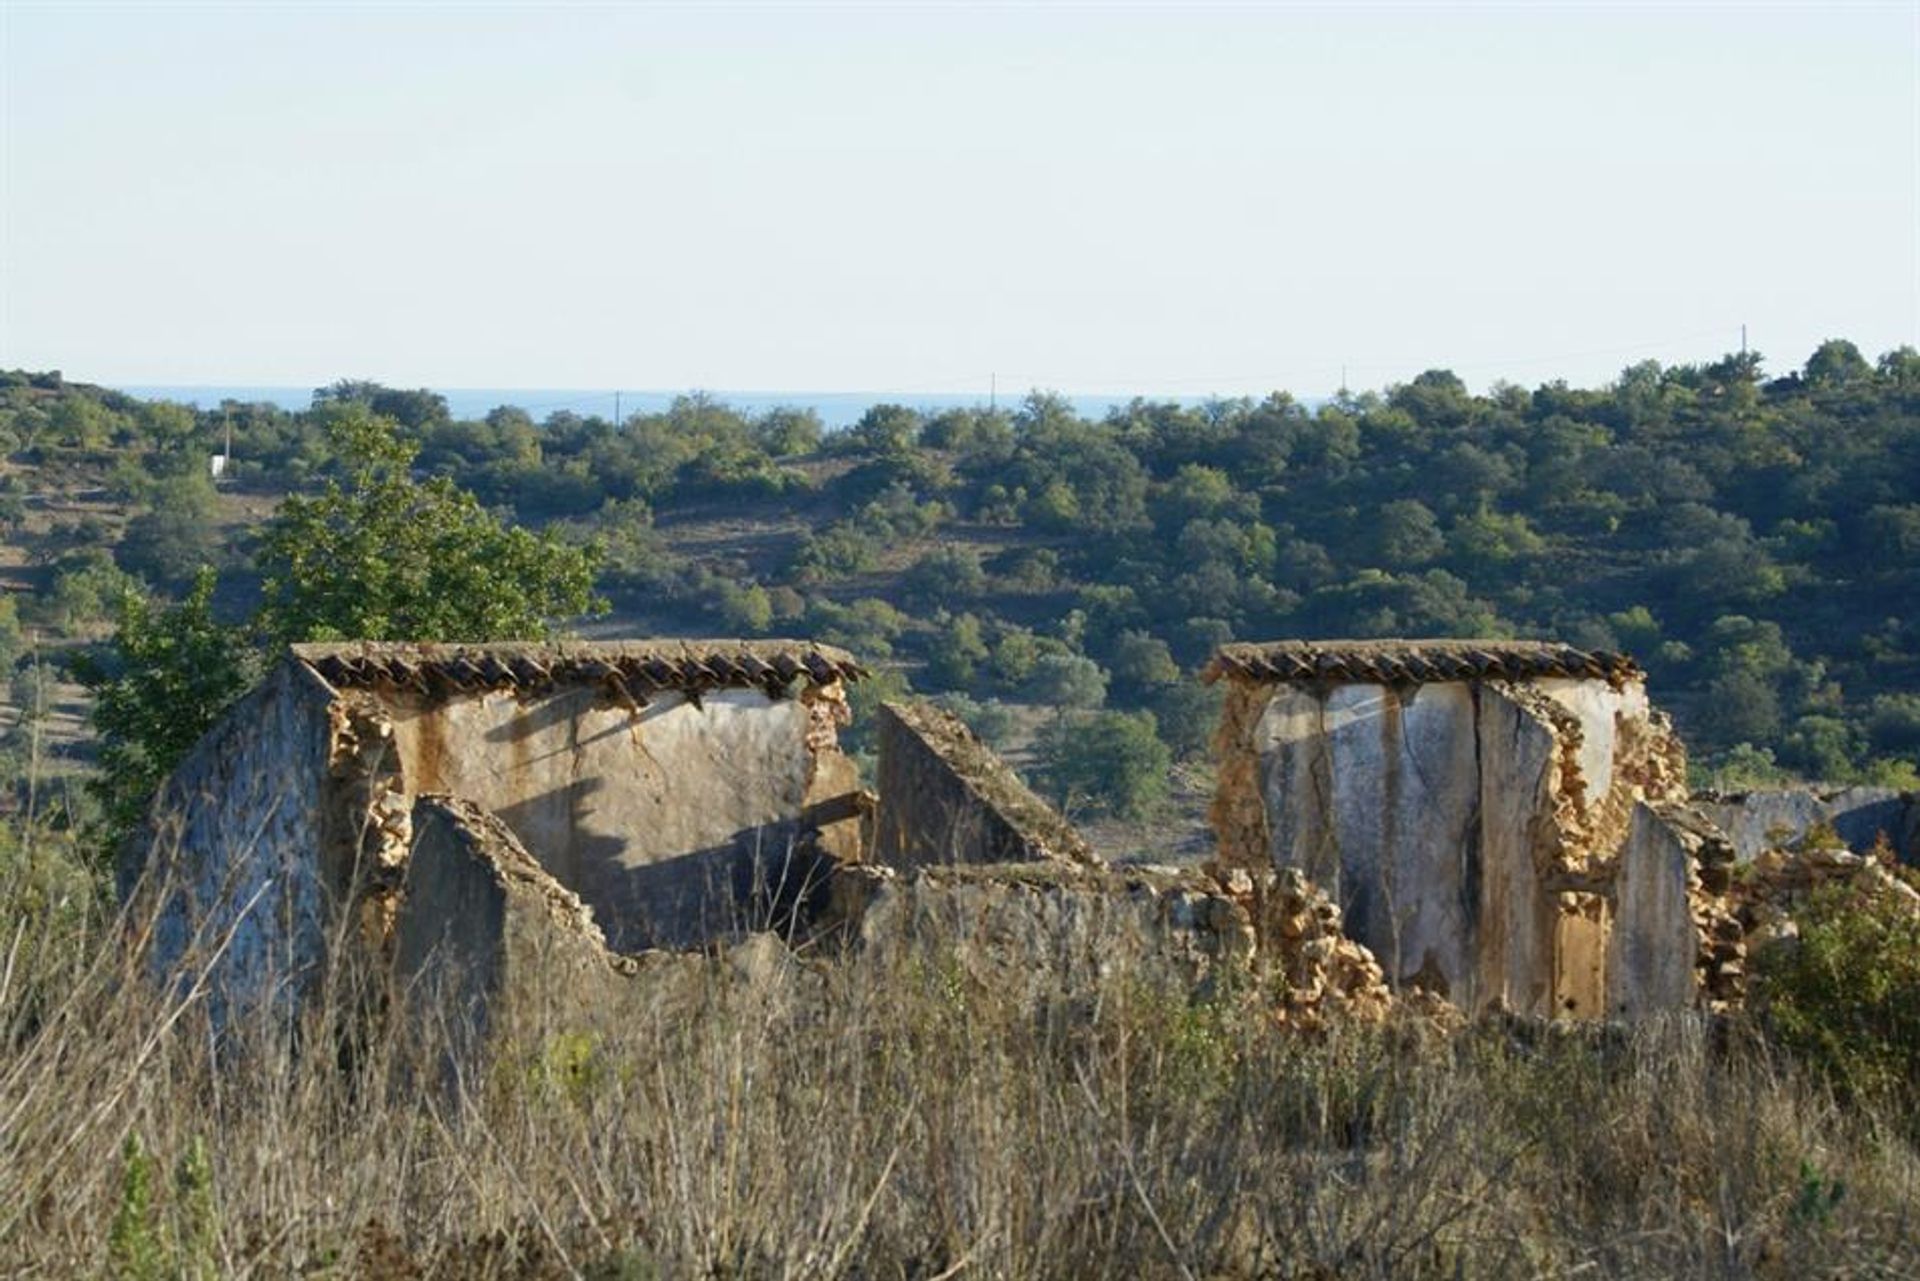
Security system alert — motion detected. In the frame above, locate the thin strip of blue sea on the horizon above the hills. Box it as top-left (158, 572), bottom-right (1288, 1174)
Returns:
top-left (115, 386), bottom-right (1188, 426)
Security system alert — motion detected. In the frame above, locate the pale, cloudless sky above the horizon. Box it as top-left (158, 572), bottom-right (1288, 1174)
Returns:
top-left (0, 0), bottom-right (1920, 396)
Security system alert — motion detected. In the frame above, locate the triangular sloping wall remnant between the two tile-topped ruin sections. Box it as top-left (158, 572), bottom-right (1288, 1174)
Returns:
top-left (874, 703), bottom-right (1100, 868)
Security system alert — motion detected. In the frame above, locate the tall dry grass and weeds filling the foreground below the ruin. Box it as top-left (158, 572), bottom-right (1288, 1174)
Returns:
top-left (0, 875), bottom-right (1920, 1277)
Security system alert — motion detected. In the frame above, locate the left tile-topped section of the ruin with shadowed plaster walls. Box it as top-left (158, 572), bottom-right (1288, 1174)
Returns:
top-left (140, 641), bottom-right (862, 999)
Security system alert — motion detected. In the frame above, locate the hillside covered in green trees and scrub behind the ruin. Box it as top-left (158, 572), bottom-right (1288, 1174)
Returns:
top-left (0, 340), bottom-right (1920, 837)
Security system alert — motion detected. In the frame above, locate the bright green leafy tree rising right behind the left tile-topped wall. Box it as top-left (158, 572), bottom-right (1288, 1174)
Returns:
top-left (255, 405), bottom-right (603, 641)
